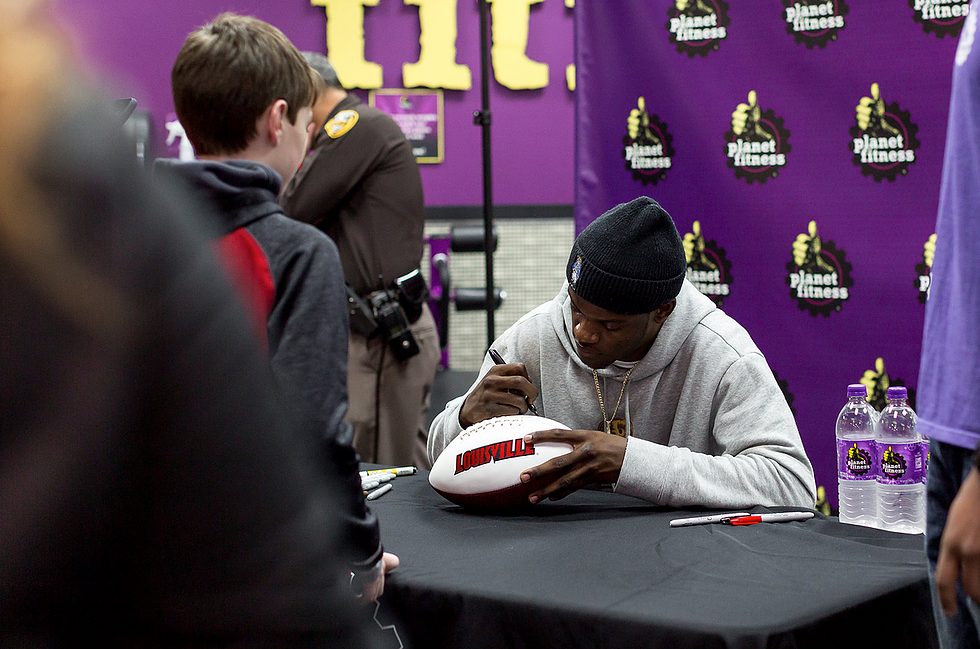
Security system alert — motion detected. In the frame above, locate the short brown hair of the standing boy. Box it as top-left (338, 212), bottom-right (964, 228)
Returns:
top-left (170, 13), bottom-right (316, 155)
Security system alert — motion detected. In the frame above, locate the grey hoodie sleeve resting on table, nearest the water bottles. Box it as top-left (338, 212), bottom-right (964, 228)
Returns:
top-left (616, 354), bottom-right (816, 508)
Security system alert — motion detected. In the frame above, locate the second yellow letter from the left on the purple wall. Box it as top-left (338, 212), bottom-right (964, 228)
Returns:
top-left (402, 0), bottom-right (473, 90)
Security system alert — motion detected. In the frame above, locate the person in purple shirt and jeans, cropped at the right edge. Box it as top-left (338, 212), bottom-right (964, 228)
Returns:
top-left (918, 0), bottom-right (980, 647)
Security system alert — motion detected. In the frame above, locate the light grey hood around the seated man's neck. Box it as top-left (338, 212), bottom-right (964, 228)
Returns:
top-left (550, 279), bottom-right (718, 380)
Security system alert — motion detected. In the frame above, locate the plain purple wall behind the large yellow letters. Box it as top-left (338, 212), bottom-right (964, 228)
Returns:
top-left (60, 0), bottom-right (573, 205)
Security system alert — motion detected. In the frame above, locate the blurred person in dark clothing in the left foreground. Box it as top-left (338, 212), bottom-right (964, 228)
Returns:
top-left (0, 0), bottom-right (372, 647)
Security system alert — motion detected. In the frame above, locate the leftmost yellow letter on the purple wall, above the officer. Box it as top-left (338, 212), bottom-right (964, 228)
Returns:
top-left (310, 0), bottom-right (383, 89)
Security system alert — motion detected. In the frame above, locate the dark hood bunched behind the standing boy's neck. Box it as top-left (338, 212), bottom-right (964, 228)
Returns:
top-left (154, 159), bottom-right (282, 234)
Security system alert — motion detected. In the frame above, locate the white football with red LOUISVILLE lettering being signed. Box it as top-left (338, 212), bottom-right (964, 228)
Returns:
top-left (429, 415), bottom-right (572, 509)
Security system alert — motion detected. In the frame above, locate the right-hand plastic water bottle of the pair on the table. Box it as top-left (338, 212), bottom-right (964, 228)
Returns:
top-left (877, 387), bottom-right (926, 534)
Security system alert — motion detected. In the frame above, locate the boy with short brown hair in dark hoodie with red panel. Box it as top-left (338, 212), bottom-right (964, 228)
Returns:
top-left (156, 13), bottom-right (398, 601)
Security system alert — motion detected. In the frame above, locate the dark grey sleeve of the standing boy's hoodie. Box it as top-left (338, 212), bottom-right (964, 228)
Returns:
top-left (260, 222), bottom-right (382, 570)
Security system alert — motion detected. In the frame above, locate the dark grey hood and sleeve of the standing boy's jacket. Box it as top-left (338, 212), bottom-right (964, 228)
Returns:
top-left (157, 160), bottom-right (382, 569)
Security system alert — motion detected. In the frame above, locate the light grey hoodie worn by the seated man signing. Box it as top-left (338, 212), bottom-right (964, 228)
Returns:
top-left (428, 281), bottom-right (816, 508)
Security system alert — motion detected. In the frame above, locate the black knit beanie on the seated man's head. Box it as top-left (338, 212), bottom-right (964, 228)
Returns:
top-left (565, 196), bottom-right (687, 315)
